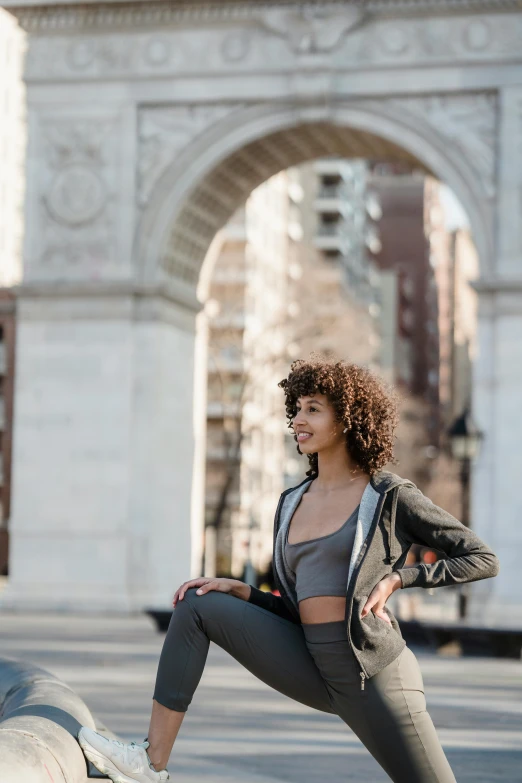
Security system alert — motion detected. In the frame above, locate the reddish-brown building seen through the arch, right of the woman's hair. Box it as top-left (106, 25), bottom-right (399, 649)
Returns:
top-left (369, 163), bottom-right (440, 490)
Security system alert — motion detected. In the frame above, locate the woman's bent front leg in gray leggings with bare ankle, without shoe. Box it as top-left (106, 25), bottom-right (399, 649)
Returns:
top-left (148, 588), bottom-right (334, 769)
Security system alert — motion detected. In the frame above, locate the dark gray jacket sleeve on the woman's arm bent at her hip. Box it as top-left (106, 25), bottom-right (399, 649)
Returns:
top-left (395, 486), bottom-right (500, 588)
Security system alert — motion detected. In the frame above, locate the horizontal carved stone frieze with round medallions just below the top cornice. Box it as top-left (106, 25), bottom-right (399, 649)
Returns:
top-left (22, 11), bottom-right (522, 81)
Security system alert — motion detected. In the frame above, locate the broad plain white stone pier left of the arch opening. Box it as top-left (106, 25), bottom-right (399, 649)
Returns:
top-left (2, 285), bottom-right (201, 611)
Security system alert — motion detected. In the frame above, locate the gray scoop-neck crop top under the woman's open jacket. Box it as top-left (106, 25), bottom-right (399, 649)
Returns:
top-left (285, 506), bottom-right (359, 601)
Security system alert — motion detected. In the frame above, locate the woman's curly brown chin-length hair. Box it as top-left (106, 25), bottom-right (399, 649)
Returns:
top-left (277, 352), bottom-right (399, 478)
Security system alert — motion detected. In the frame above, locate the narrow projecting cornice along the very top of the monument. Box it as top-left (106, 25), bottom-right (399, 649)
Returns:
top-left (7, 0), bottom-right (522, 33)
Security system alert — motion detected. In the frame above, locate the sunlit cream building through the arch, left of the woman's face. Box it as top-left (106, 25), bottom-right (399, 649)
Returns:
top-left (205, 172), bottom-right (292, 578)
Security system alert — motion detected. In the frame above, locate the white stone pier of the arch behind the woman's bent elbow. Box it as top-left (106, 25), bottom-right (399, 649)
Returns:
top-left (471, 86), bottom-right (522, 627)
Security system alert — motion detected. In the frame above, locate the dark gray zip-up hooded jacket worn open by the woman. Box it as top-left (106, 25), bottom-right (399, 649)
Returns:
top-left (248, 471), bottom-right (499, 689)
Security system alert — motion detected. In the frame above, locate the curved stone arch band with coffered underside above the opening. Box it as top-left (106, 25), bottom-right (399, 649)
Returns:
top-left (136, 101), bottom-right (493, 290)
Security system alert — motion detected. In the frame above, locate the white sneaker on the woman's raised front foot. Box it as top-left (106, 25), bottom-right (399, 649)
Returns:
top-left (78, 726), bottom-right (170, 783)
